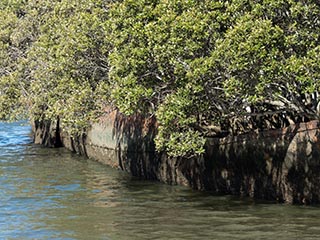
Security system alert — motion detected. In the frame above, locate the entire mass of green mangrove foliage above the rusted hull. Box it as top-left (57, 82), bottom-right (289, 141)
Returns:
top-left (0, 0), bottom-right (320, 156)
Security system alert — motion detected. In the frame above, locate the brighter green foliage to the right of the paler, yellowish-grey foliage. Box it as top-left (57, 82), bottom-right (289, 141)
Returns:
top-left (108, 0), bottom-right (319, 156)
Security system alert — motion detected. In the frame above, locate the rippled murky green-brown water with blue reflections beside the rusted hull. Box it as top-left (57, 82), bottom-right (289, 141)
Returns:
top-left (0, 123), bottom-right (320, 240)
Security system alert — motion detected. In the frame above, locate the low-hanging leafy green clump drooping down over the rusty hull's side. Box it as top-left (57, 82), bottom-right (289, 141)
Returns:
top-left (155, 87), bottom-right (205, 156)
